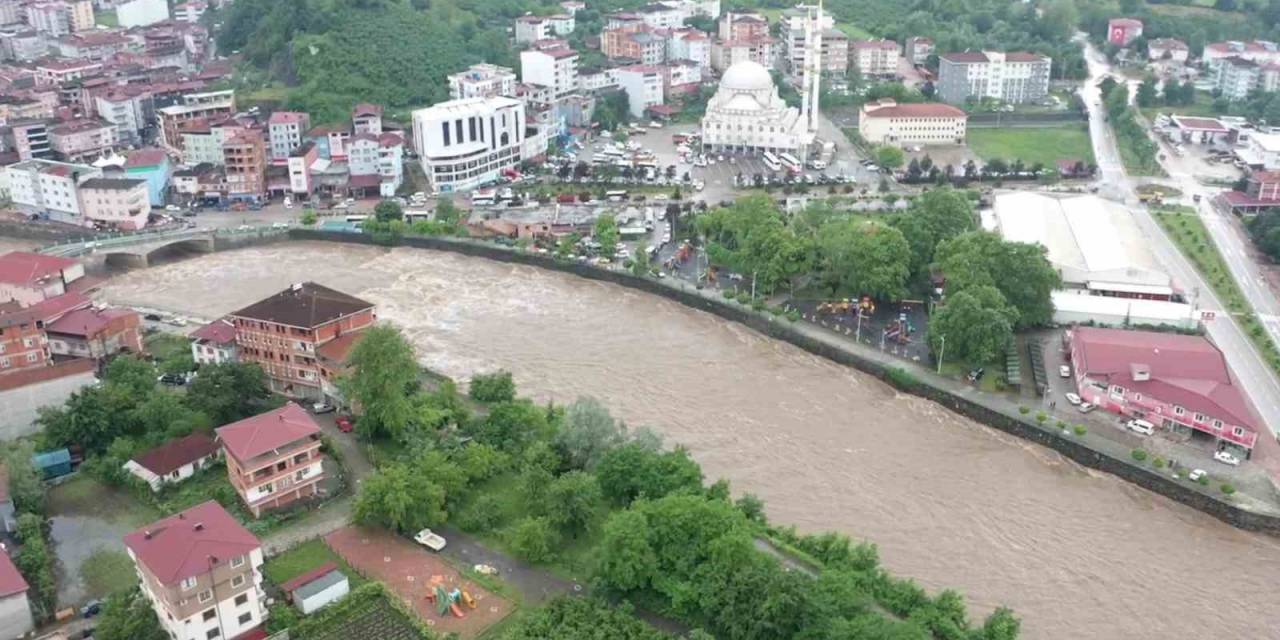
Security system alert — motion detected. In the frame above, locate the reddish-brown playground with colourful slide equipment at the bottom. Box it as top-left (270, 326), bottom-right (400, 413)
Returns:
top-left (324, 526), bottom-right (513, 639)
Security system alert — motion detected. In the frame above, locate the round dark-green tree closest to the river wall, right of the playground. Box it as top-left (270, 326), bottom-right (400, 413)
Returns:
top-left (929, 285), bottom-right (1018, 365)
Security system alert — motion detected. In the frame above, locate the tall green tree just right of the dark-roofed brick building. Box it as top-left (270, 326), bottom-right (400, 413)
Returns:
top-left (338, 325), bottom-right (420, 438)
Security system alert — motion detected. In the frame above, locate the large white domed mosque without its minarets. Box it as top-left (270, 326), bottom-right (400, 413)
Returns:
top-left (703, 61), bottom-right (813, 154)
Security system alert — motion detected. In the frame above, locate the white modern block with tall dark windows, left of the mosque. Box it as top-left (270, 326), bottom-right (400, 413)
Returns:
top-left (413, 97), bottom-right (525, 193)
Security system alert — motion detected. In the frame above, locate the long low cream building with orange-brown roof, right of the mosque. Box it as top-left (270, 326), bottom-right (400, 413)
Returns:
top-left (858, 99), bottom-right (969, 146)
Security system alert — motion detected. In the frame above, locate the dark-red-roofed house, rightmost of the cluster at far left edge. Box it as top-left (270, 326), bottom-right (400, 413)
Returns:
top-left (45, 307), bottom-right (142, 360)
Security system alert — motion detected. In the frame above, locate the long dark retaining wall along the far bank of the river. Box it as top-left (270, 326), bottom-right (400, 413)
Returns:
top-left (289, 229), bottom-right (1280, 536)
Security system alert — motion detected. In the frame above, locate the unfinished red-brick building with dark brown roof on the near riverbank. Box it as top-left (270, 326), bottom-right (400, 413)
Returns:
top-left (229, 282), bottom-right (378, 398)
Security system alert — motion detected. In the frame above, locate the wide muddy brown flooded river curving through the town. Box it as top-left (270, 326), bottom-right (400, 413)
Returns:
top-left (102, 243), bottom-right (1280, 640)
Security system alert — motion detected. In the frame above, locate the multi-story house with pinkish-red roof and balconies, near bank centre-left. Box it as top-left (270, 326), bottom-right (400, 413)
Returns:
top-left (218, 402), bottom-right (324, 517)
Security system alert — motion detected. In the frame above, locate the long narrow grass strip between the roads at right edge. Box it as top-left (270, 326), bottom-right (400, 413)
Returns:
top-left (1152, 206), bottom-right (1280, 371)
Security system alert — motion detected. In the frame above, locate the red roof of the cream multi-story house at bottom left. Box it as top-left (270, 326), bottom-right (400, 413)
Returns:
top-left (124, 500), bottom-right (261, 586)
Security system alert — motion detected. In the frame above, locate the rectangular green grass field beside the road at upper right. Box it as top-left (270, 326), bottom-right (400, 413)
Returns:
top-left (968, 124), bottom-right (1093, 166)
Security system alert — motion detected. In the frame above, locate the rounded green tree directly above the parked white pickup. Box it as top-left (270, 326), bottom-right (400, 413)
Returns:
top-left (353, 463), bottom-right (448, 534)
